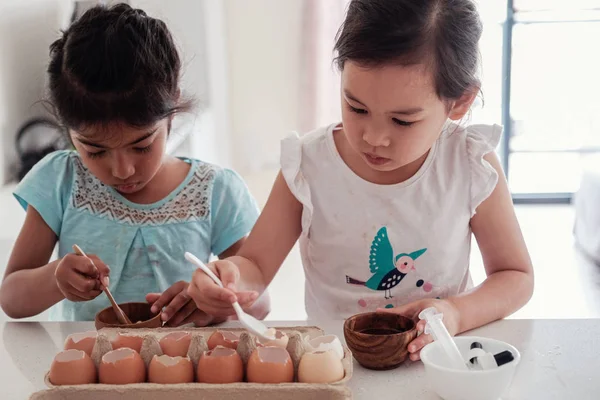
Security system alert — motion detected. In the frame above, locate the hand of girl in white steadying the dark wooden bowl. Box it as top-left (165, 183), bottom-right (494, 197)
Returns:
top-left (377, 299), bottom-right (460, 361)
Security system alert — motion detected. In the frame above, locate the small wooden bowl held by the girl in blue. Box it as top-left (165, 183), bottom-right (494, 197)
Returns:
top-left (96, 303), bottom-right (163, 329)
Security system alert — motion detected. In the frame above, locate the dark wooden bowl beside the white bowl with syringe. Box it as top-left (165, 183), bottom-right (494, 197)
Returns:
top-left (344, 312), bottom-right (417, 370)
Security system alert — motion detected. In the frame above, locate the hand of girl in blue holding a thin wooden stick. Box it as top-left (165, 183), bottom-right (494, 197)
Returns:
top-left (54, 254), bottom-right (110, 301)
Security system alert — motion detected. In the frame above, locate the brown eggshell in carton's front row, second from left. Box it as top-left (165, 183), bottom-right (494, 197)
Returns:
top-left (98, 347), bottom-right (146, 385)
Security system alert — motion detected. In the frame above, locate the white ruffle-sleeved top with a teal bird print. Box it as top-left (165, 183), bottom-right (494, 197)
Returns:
top-left (281, 124), bottom-right (502, 319)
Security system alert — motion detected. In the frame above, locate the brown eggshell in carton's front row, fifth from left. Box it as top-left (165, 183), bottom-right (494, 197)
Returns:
top-left (247, 346), bottom-right (294, 383)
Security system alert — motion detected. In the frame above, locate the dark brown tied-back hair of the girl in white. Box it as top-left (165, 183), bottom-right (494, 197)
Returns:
top-left (335, 0), bottom-right (482, 100)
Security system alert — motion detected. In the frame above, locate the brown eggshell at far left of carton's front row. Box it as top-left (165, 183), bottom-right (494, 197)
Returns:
top-left (48, 349), bottom-right (97, 386)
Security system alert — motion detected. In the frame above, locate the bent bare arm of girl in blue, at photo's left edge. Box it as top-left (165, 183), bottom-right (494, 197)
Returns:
top-left (0, 207), bottom-right (64, 318)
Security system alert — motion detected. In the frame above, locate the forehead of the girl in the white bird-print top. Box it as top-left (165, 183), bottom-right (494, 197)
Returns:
top-left (342, 62), bottom-right (441, 111)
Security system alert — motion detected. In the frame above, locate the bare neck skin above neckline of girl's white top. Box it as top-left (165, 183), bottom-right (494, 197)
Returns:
top-left (333, 130), bottom-right (431, 185)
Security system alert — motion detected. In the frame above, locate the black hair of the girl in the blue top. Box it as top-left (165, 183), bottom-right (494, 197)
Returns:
top-left (48, 4), bottom-right (191, 129)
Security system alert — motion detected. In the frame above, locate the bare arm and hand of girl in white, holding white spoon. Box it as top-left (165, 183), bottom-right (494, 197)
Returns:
top-left (188, 172), bottom-right (302, 316)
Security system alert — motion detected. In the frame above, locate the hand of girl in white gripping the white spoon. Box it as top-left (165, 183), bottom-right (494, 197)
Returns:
top-left (187, 260), bottom-right (258, 318)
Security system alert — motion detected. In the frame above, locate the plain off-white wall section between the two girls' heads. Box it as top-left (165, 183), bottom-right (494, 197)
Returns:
top-left (225, 0), bottom-right (303, 172)
